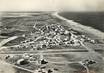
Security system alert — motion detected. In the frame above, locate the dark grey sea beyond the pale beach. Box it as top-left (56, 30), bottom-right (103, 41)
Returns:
top-left (59, 12), bottom-right (104, 32)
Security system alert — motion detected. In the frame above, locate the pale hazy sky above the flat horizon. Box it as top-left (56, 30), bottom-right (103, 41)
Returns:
top-left (0, 0), bottom-right (104, 11)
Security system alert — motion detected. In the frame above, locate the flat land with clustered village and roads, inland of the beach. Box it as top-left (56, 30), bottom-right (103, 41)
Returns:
top-left (0, 12), bottom-right (104, 73)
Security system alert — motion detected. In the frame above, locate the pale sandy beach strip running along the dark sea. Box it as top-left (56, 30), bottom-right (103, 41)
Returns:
top-left (53, 12), bottom-right (104, 39)
